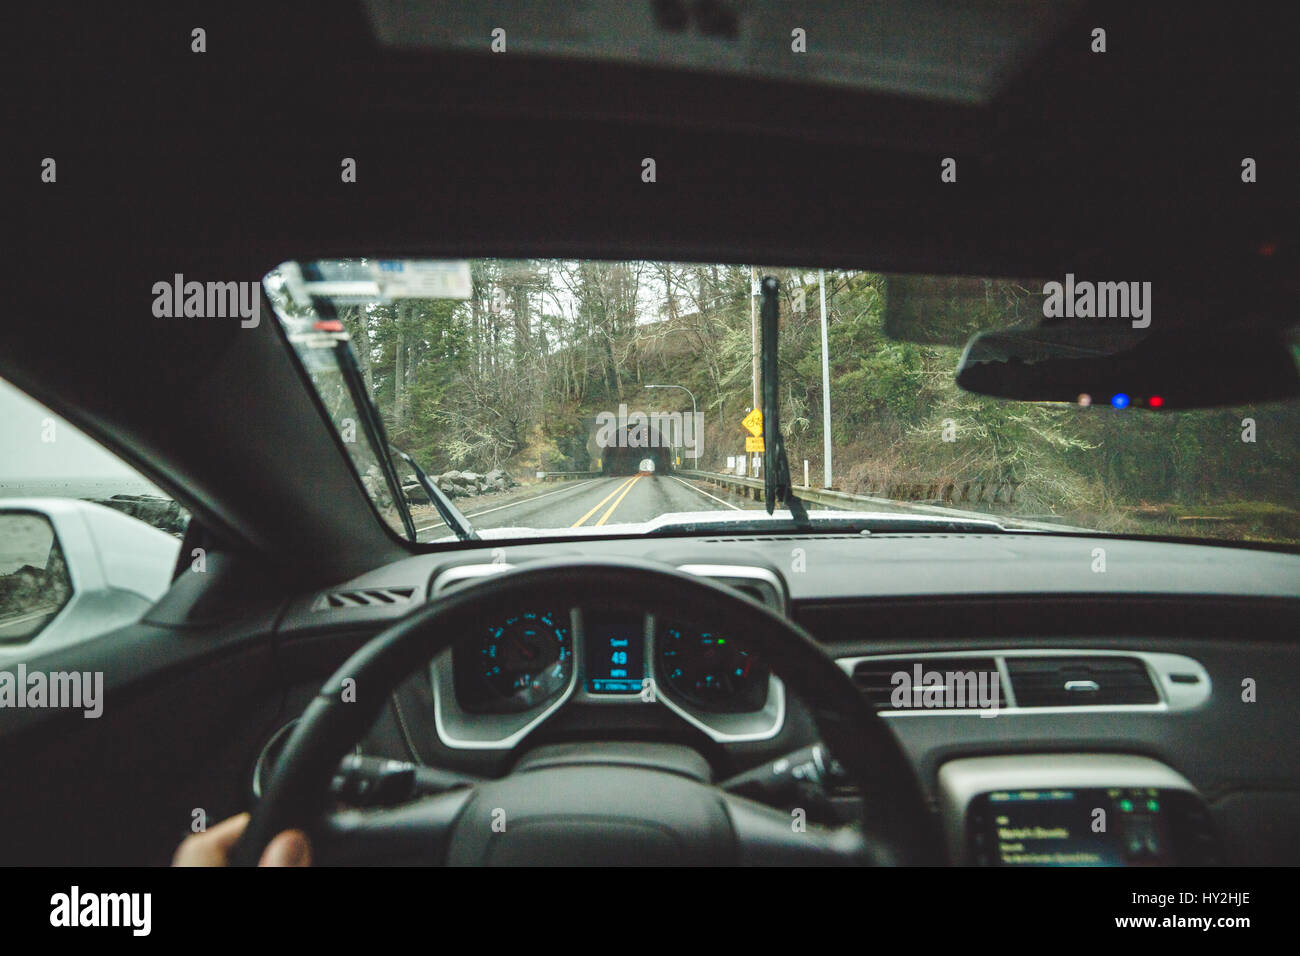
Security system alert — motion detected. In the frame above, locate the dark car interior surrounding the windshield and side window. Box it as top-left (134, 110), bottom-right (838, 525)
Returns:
top-left (0, 0), bottom-right (1300, 866)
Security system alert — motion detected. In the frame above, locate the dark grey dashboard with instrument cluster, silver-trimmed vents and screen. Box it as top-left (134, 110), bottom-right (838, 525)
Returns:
top-left (271, 535), bottom-right (1300, 866)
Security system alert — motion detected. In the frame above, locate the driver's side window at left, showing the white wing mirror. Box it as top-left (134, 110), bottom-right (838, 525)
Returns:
top-left (0, 380), bottom-right (189, 658)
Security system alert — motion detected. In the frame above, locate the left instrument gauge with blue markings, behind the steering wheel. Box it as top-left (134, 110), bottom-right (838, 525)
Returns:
top-left (456, 611), bottom-right (573, 711)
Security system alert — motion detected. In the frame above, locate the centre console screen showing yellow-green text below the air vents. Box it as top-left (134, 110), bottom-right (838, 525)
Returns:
top-left (967, 787), bottom-right (1174, 866)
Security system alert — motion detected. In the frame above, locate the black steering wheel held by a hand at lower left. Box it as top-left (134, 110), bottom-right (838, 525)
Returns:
top-left (231, 561), bottom-right (943, 865)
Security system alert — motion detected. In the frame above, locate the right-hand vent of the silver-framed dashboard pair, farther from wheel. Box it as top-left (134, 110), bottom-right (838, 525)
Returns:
top-left (1006, 654), bottom-right (1160, 708)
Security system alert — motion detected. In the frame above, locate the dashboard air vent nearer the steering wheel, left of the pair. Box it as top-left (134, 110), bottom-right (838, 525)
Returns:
top-left (853, 657), bottom-right (1006, 710)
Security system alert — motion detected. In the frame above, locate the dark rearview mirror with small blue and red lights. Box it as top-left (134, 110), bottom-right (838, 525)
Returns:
top-left (957, 325), bottom-right (1300, 410)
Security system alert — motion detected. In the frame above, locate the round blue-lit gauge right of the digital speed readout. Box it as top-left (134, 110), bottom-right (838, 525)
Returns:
top-left (657, 626), bottom-right (768, 713)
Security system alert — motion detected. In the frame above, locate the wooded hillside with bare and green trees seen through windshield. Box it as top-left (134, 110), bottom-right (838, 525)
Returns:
top-left (330, 260), bottom-right (1300, 540)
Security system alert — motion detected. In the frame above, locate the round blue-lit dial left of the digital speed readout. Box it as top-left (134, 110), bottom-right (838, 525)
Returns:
top-left (478, 611), bottom-right (573, 708)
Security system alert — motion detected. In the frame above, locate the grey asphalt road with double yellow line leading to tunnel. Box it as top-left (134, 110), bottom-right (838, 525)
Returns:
top-left (421, 475), bottom-right (763, 540)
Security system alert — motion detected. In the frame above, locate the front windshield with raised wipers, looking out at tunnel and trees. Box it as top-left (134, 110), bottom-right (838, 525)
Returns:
top-left (258, 259), bottom-right (1300, 544)
